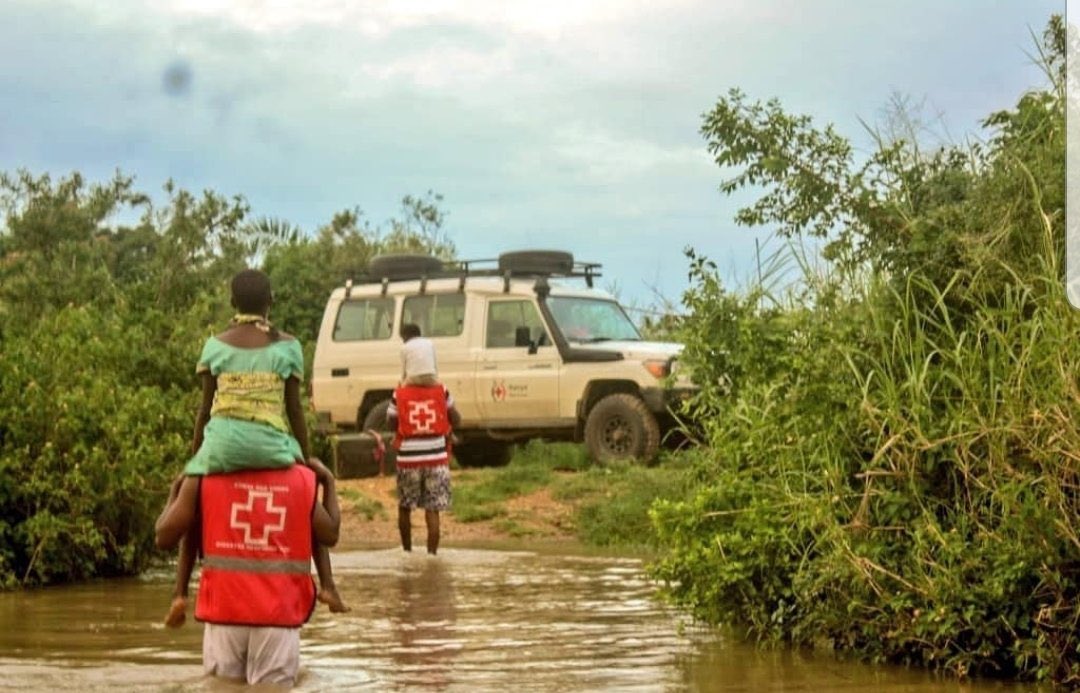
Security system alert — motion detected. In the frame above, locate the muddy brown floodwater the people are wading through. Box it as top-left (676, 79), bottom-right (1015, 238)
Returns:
top-left (0, 547), bottom-right (1038, 693)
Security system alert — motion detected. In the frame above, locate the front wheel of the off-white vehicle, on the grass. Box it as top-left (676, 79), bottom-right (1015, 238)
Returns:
top-left (585, 393), bottom-right (660, 462)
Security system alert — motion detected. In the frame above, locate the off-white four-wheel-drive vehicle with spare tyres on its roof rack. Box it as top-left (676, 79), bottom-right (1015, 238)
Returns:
top-left (311, 250), bottom-right (691, 464)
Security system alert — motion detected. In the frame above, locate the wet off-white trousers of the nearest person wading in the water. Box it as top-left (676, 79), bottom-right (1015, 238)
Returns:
top-left (203, 623), bottom-right (300, 685)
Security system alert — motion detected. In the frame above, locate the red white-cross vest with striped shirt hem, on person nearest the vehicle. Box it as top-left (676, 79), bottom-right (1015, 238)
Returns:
top-left (394, 385), bottom-right (450, 468)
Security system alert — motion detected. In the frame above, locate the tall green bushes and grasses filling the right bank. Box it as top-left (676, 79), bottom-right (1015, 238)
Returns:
top-left (651, 17), bottom-right (1080, 685)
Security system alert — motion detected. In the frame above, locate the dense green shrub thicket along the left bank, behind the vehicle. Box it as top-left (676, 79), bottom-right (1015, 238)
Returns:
top-left (0, 173), bottom-right (453, 588)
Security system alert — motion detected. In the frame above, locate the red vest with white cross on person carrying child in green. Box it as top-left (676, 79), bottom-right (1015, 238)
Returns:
top-left (195, 464), bottom-right (316, 627)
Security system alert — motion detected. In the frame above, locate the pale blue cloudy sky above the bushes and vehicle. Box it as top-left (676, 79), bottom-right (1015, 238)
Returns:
top-left (0, 0), bottom-right (1065, 304)
